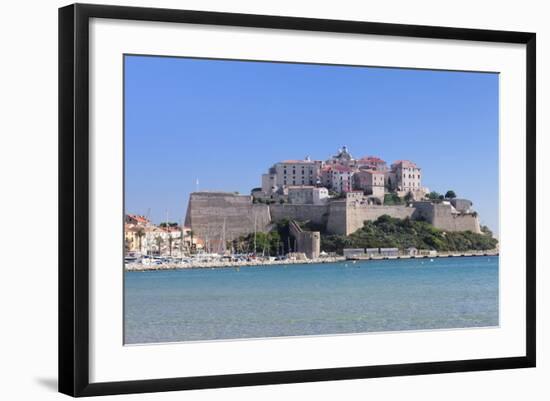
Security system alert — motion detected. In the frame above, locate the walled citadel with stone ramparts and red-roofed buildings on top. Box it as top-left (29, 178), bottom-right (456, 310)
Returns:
top-left (185, 146), bottom-right (481, 253)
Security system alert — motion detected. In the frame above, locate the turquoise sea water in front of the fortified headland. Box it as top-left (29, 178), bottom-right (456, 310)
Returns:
top-left (124, 257), bottom-right (499, 344)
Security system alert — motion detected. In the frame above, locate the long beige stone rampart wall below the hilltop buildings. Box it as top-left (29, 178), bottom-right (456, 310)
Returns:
top-left (185, 192), bottom-right (481, 240)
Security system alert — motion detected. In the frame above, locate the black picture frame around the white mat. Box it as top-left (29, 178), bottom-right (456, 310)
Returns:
top-left (59, 4), bottom-right (536, 396)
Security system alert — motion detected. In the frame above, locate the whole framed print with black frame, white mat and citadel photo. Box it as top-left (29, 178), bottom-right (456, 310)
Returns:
top-left (59, 4), bottom-right (536, 396)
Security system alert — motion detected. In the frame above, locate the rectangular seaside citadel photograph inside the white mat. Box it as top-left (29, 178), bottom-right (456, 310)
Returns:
top-left (121, 54), bottom-right (500, 345)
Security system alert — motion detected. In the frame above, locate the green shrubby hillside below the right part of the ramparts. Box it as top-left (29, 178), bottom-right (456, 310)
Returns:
top-left (321, 215), bottom-right (498, 253)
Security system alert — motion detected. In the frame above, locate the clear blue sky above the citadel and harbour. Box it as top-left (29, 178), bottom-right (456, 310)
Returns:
top-left (125, 56), bottom-right (498, 232)
